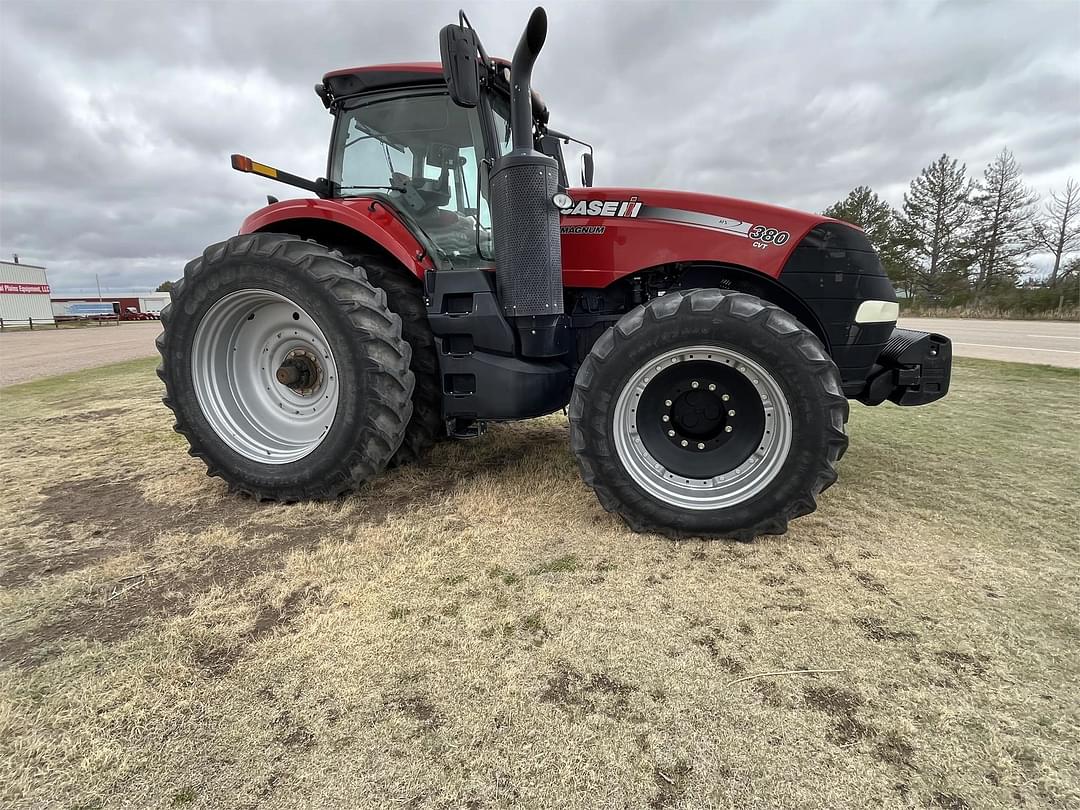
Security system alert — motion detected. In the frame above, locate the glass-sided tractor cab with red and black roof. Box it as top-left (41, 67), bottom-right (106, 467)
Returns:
top-left (315, 60), bottom-right (583, 268)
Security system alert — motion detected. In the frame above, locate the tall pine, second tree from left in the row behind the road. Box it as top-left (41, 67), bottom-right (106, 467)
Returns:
top-left (899, 154), bottom-right (971, 295)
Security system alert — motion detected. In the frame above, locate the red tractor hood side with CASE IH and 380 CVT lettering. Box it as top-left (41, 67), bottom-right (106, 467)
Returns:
top-left (554, 188), bottom-right (855, 286)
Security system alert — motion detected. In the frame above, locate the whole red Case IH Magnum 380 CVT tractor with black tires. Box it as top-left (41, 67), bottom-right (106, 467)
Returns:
top-left (159, 9), bottom-right (951, 538)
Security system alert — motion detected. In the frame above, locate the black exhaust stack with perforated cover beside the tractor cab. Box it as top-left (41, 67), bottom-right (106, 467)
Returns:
top-left (490, 8), bottom-right (569, 357)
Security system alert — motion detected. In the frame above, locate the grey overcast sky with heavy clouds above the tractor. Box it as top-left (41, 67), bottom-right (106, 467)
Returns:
top-left (0, 0), bottom-right (1080, 291)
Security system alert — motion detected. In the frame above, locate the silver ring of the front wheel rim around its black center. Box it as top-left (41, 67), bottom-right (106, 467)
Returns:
top-left (612, 346), bottom-right (792, 511)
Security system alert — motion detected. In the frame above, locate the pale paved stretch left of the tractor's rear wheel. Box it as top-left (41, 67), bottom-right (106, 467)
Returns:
top-left (0, 321), bottom-right (161, 386)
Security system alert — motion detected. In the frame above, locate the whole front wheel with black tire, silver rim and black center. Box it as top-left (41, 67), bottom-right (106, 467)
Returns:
top-left (569, 289), bottom-right (848, 540)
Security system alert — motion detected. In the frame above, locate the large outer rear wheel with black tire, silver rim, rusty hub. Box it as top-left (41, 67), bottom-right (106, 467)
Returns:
top-left (158, 233), bottom-right (414, 501)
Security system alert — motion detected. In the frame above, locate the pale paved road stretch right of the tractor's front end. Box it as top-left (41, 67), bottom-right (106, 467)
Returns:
top-left (900, 318), bottom-right (1080, 368)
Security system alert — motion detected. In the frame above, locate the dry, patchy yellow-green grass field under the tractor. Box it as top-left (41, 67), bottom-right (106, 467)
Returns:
top-left (0, 361), bottom-right (1080, 810)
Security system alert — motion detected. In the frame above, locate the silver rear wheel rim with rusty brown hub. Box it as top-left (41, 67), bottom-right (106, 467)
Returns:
top-left (191, 289), bottom-right (339, 464)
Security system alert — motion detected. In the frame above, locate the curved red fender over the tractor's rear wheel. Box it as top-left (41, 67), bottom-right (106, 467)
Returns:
top-left (240, 198), bottom-right (434, 279)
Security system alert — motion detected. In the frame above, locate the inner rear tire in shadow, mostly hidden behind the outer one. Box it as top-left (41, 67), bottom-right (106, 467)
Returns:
top-left (346, 254), bottom-right (446, 467)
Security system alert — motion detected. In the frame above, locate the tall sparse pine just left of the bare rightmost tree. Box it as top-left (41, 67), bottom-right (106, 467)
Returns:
top-left (971, 149), bottom-right (1038, 301)
